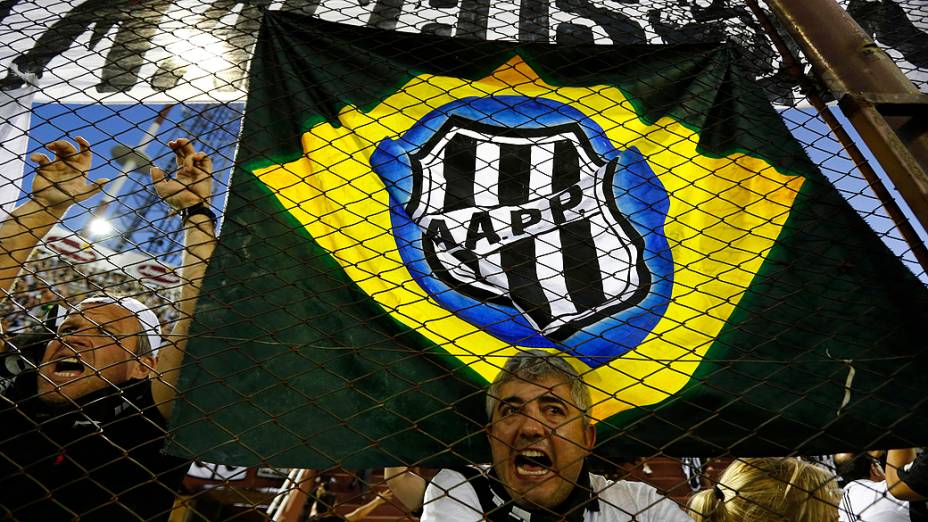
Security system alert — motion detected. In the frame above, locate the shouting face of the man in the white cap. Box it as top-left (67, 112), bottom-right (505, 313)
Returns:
top-left (38, 303), bottom-right (154, 403)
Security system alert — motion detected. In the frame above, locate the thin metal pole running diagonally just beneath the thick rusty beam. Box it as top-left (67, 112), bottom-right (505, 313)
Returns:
top-left (746, 0), bottom-right (928, 272)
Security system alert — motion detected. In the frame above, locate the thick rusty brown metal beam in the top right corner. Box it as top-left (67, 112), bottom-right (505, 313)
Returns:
top-left (767, 0), bottom-right (928, 230)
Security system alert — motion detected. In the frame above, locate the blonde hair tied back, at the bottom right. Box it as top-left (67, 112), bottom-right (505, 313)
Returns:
top-left (687, 458), bottom-right (841, 522)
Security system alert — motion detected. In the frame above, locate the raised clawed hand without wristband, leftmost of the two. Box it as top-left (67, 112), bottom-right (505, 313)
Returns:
top-left (29, 136), bottom-right (109, 209)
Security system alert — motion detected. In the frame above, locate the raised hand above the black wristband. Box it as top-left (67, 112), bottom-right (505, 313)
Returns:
top-left (151, 138), bottom-right (213, 210)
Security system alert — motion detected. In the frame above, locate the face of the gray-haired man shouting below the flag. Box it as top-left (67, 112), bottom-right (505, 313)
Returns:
top-left (488, 376), bottom-right (596, 508)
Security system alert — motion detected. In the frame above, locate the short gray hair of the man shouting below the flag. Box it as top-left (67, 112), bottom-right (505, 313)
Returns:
top-left (487, 350), bottom-right (592, 422)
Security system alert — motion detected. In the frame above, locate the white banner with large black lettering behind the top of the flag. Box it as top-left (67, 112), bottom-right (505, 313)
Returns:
top-left (0, 0), bottom-right (928, 105)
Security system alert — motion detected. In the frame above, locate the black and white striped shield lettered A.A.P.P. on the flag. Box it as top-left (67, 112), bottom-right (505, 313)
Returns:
top-left (406, 117), bottom-right (650, 340)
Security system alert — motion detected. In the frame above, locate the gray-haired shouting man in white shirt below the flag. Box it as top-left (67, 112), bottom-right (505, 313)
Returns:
top-left (416, 350), bottom-right (690, 522)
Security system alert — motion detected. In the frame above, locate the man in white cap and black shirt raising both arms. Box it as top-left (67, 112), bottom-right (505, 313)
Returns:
top-left (0, 138), bottom-right (215, 521)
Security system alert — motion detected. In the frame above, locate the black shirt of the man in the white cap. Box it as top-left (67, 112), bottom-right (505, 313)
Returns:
top-left (0, 366), bottom-right (189, 522)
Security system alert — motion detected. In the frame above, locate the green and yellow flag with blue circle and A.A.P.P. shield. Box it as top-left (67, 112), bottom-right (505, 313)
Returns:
top-left (172, 12), bottom-right (928, 468)
